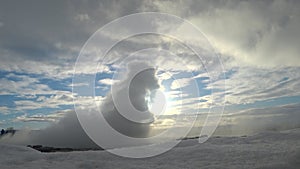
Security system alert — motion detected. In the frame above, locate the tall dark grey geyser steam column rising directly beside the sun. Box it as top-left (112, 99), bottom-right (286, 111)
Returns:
top-left (101, 62), bottom-right (159, 138)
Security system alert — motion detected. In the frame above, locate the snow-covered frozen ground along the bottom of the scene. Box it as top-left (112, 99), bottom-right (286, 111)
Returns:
top-left (0, 129), bottom-right (300, 169)
